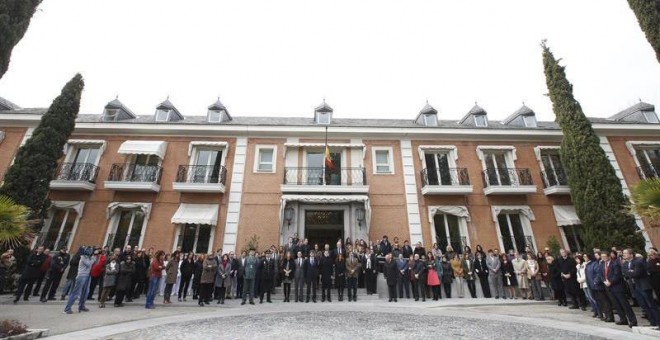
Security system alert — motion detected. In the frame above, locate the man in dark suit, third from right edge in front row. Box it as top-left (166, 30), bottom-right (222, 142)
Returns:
top-left (601, 251), bottom-right (637, 327)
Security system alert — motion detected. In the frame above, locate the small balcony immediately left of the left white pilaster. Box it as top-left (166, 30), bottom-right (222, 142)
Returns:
top-left (172, 165), bottom-right (227, 194)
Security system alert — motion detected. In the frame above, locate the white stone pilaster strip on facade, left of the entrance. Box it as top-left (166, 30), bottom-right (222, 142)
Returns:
top-left (222, 137), bottom-right (250, 252)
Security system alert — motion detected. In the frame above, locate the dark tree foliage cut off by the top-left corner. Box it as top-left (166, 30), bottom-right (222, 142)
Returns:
top-left (0, 0), bottom-right (41, 78)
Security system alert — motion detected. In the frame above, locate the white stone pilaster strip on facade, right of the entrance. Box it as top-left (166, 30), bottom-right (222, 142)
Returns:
top-left (401, 139), bottom-right (424, 244)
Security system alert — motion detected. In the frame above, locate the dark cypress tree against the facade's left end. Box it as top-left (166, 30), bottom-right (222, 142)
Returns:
top-left (0, 74), bottom-right (84, 218)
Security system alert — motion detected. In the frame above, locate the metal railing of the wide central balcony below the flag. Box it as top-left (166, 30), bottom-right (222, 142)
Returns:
top-left (284, 167), bottom-right (367, 186)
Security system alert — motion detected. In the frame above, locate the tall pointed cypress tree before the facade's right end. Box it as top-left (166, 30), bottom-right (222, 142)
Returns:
top-left (542, 42), bottom-right (644, 250)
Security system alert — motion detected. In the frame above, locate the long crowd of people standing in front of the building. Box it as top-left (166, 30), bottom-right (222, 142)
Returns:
top-left (0, 236), bottom-right (660, 327)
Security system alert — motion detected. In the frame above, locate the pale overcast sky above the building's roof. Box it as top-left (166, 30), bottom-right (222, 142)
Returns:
top-left (0, 0), bottom-right (660, 120)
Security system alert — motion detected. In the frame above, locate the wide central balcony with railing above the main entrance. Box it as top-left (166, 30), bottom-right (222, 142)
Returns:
top-left (282, 167), bottom-right (369, 194)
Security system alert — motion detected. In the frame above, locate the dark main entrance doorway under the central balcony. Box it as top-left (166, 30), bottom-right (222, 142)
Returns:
top-left (305, 210), bottom-right (344, 250)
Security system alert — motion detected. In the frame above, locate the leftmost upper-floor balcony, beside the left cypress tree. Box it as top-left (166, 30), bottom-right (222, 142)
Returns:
top-left (50, 163), bottom-right (99, 191)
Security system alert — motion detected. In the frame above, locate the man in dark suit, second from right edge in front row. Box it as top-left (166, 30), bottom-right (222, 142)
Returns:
top-left (623, 249), bottom-right (660, 326)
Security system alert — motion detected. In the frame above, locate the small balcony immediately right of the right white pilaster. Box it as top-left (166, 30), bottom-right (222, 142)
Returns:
top-left (421, 168), bottom-right (473, 195)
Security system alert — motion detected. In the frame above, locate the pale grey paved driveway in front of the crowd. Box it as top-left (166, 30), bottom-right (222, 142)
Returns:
top-left (0, 296), bottom-right (660, 339)
